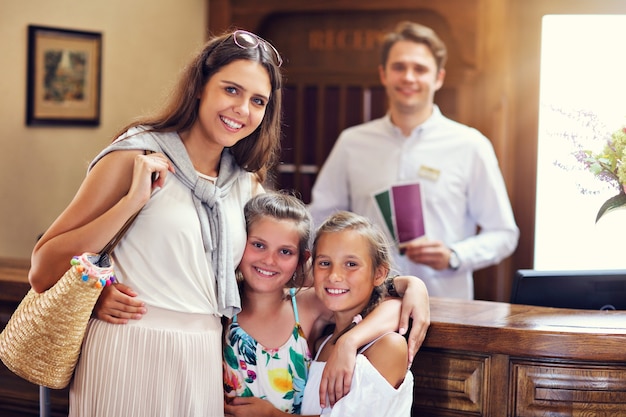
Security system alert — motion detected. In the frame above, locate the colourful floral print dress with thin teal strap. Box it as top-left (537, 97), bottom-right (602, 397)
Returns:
top-left (224, 288), bottom-right (311, 414)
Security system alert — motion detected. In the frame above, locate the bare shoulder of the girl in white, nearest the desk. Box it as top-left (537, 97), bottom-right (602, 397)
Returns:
top-left (364, 333), bottom-right (408, 388)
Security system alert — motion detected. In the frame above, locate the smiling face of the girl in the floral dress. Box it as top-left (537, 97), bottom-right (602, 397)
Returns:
top-left (239, 216), bottom-right (300, 292)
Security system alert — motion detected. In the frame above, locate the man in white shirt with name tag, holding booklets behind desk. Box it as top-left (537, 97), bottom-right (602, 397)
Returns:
top-left (309, 22), bottom-right (519, 299)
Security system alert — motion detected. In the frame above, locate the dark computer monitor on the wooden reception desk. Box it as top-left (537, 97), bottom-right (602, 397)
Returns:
top-left (511, 269), bottom-right (626, 310)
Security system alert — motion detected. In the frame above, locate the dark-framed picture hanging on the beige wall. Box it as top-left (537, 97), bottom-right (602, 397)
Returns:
top-left (26, 25), bottom-right (102, 126)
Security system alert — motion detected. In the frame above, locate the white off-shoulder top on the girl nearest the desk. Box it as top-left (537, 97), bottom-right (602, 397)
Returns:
top-left (302, 335), bottom-right (413, 417)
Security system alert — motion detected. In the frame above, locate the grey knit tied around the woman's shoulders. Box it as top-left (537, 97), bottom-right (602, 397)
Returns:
top-left (89, 127), bottom-right (244, 317)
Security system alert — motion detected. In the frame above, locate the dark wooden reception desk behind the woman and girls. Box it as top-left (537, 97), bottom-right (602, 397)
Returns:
top-left (0, 259), bottom-right (626, 417)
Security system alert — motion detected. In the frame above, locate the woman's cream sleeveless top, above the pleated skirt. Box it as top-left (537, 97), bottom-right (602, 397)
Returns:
top-left (113, 174), bottom-right (252, 315)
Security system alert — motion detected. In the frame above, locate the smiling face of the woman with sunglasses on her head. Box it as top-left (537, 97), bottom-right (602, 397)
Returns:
top-left (192, 60), bottom-right (272, 148)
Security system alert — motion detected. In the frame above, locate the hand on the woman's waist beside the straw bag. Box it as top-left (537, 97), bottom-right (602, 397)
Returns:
top-left (93, 284), bottom-right (146, 324)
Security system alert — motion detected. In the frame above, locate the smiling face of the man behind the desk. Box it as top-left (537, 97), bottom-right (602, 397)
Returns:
top-left (379, 40), bottom-right (445, 116)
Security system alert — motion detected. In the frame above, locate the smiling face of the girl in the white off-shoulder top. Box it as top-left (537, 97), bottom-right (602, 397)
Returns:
top-left (313, 229), bottom-right (387, 326)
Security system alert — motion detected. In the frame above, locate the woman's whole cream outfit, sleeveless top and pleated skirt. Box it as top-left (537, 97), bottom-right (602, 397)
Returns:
top-left (69, 170), bottom-right (252, 417)
